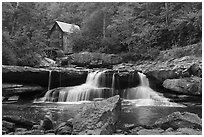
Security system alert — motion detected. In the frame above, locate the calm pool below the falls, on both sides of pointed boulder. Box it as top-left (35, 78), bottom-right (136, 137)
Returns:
top-left (2, 99), bottom-right (202, 128)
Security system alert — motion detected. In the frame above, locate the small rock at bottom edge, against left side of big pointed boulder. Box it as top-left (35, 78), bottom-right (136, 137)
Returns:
top-left (55, 119), bottom-right (73, 135)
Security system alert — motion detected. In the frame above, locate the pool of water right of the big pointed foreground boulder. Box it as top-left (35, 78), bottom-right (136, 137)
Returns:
top-left (119, 101), bottom-right (202, 126)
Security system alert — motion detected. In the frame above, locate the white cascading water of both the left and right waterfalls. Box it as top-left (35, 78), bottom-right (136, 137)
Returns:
top-left (43, 70), bottom-right (171, 104)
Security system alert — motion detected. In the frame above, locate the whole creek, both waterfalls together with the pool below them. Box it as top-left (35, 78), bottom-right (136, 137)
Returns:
top-left (2, 71), bottom-right (202, 131)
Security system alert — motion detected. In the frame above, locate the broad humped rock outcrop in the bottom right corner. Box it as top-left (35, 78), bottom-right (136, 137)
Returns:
top-left (126, 112), bottom-right (202, 135)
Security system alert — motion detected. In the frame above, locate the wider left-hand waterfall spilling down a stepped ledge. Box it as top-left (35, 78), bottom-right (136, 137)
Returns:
top-left (44, 71), bottom-right (114, 102)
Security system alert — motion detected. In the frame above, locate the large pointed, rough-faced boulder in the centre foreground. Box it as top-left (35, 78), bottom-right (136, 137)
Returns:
top-left (73, 95), bottom-right (121, 135)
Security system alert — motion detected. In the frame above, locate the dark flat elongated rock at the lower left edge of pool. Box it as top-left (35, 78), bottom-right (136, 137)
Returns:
top-left (2, 116), bottom-right (36, 129)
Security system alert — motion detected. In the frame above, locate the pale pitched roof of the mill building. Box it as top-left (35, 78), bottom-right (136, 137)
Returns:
top-left (53, 21), bottom-right (80, 33)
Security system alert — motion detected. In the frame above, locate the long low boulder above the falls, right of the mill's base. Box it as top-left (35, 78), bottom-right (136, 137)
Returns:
top-left (62, 52), bottom-right (122, 68)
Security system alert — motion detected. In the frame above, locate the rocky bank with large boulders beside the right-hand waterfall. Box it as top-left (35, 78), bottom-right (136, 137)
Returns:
top-left (113, 56), bottom-right (202, 95)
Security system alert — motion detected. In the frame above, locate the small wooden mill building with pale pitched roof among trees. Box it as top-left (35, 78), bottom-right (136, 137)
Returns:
top-left (49, 21), bottom-right (80, 53)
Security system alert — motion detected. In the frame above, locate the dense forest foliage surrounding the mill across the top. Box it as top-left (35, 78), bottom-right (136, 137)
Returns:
top-left (2, 2), bottom-right (202, 66)
